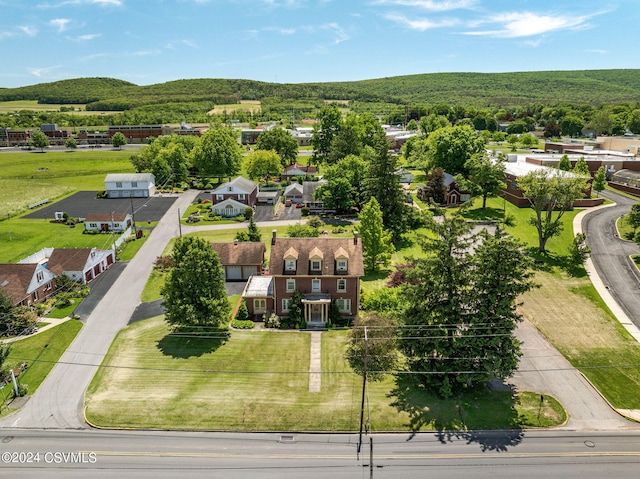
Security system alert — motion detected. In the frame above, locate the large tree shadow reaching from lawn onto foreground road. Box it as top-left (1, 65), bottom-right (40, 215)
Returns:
top-left (389, 376), bottom-right (524, 452)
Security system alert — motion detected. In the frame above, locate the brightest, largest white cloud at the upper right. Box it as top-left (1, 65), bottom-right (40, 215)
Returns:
top-left (463, 12), bottom-right (590, 38)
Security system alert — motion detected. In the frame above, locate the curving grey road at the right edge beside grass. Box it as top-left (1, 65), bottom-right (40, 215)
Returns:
top-left (582, 191), bottom-right (640, 328)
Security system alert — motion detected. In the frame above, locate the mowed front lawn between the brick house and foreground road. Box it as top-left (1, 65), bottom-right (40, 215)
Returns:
top-left (85, 317), bottom-right (565, 431)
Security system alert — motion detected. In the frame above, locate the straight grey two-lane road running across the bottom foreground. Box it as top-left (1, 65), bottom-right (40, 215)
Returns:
top-left (0, 430), bottom-right (640, 479)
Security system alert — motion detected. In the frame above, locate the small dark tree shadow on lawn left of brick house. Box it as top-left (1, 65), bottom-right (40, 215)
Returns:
top-left (156, 329), bottom-right (229, 359)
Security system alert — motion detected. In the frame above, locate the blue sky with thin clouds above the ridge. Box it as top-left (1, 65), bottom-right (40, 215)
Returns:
top-left (0, 0), bottom-right (640, 87)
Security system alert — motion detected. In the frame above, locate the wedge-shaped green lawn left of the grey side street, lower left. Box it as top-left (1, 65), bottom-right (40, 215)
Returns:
top-left (5, 319), bottom-right (82, 394)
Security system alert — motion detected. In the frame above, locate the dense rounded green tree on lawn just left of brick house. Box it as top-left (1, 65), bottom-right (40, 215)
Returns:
top-left (162, 236), bottom-right (231, 332)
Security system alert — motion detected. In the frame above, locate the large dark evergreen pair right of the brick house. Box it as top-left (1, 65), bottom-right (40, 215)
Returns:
top-left (400, 215), bottom-right (533, 397)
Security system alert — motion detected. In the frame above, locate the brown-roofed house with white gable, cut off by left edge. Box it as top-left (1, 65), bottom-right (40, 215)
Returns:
top-left (0, 263), bottom-right (56, 306)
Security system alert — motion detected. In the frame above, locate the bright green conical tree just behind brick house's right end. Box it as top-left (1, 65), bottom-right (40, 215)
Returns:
top-left (358, 197), bottom-right (395, 272)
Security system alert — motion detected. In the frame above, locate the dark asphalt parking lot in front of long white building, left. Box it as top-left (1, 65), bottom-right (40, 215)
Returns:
top-left (24, 191), bottom-right (177, 222)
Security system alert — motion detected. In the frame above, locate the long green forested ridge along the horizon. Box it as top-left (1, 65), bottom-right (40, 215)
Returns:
top-left (0, 69), bottom-right (640, 111)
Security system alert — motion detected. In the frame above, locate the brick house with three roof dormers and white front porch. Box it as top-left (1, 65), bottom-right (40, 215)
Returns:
top-left (269, 230), bottom-right (364, 326)
